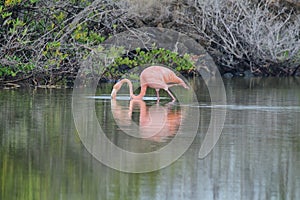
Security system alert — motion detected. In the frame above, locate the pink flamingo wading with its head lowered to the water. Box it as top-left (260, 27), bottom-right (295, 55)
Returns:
top-left (111, 66), bottom-right (189, 101)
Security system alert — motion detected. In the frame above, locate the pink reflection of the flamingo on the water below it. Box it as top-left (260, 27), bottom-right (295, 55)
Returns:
top-left (111, 99), bottom-right (183, 142)
